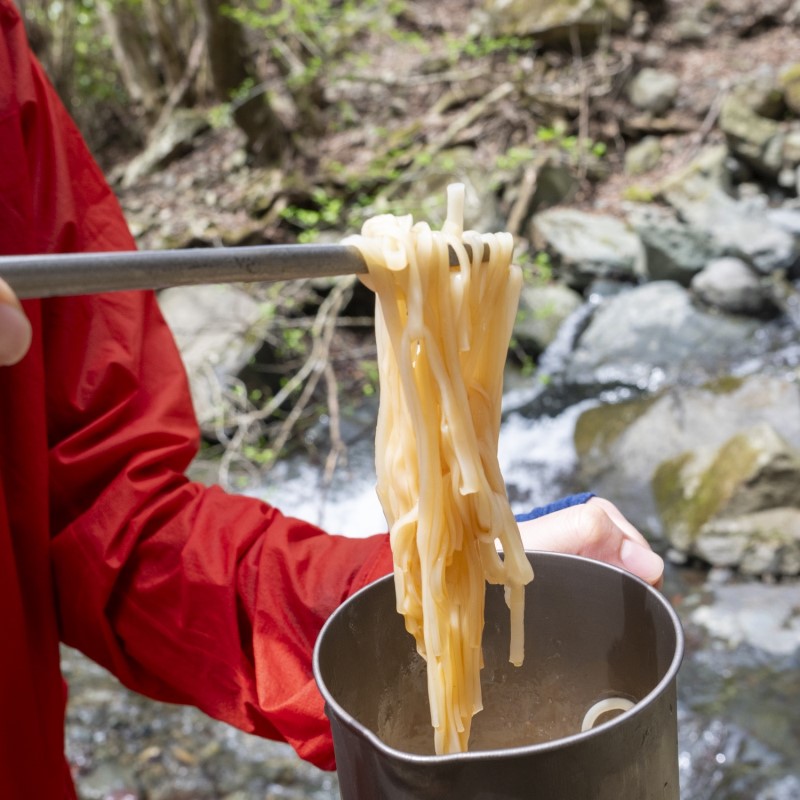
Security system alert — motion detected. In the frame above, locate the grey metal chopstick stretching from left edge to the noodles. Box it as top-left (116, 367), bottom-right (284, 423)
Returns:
top-left (0, 244), bottom-right (367, 298)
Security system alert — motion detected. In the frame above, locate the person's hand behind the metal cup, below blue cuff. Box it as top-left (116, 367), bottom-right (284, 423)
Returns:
top-left (519, 497), bottom-right (664, 587)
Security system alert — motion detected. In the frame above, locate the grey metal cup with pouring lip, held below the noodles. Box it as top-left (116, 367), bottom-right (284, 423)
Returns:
top-left (314, 552), bottom-right (683, 800)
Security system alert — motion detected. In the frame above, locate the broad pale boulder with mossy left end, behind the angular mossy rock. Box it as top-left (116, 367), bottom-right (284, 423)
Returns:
top-left (575, 372), bottom-right (800, 533)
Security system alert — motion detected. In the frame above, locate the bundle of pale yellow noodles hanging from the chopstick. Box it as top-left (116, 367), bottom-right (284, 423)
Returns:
top-left (347, 184), bottom-right (533, 754)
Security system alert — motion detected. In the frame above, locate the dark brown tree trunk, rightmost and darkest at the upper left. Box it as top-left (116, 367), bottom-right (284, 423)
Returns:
top-left (199, 0), bottom-right (290, 165)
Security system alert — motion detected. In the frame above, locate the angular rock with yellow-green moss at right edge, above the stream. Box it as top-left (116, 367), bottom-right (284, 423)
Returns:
top-left (652, 423), bottom-right (800, 574)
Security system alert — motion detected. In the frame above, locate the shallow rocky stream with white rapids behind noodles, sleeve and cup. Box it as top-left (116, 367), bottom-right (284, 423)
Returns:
top-left (64, 376), bottom-right (800, 800)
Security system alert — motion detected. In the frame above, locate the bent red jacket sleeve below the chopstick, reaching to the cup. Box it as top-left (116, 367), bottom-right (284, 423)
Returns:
top-left (43, 293), bottom-right (391, 767)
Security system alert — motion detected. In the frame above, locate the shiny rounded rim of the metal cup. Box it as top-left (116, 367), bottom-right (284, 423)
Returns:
top-left (312, 550), bottom-right (685, 765)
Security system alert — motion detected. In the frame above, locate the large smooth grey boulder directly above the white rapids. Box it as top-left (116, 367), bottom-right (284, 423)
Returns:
top-left (561, 281), bottom-right (758, 393)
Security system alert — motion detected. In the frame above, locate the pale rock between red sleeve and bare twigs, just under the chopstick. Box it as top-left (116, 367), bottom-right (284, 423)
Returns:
top-left (159, 284), bottom-right (271, 436)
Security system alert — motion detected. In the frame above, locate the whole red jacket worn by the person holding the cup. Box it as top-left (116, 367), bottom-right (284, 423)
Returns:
top-left (0, 0), bottom-right (391, 800)
